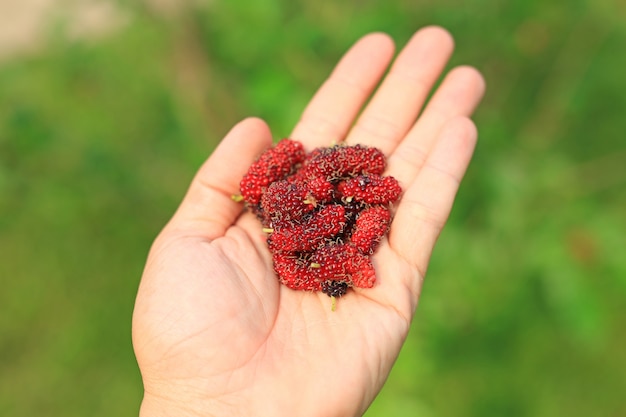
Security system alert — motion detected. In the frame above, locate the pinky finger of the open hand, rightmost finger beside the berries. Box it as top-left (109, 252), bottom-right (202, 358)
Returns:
top-left (389, 117), bottom-right (477, 277)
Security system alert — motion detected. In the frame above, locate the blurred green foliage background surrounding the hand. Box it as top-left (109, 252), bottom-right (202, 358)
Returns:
top-left (0, 0), bottom-right (626, 417)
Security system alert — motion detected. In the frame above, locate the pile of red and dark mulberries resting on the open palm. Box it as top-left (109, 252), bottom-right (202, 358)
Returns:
top-left (234, 139), bottom-right (402, 298)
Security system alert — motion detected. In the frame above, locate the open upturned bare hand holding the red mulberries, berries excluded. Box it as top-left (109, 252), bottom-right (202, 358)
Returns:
top-left (133, 27), bottom-right (484, 416)
